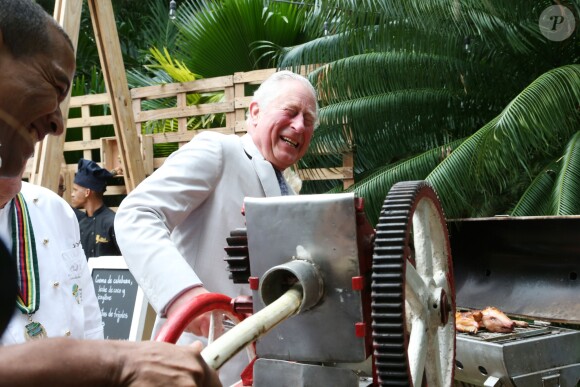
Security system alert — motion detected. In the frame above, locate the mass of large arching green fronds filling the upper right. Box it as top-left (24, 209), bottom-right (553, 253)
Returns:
top-left (288, 0), bottom-right (580, 223)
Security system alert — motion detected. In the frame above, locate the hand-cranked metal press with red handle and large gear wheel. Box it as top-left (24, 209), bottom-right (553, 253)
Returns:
top-left (157, 181), bottom-right (455, 387)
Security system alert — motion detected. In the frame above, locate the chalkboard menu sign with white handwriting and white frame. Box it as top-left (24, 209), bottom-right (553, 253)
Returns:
top-left (88, 256), bottom-right (147, 341)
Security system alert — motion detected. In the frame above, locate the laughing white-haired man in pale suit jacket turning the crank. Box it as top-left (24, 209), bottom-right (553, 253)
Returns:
top-left (115, 71), bottom-right (318, 386)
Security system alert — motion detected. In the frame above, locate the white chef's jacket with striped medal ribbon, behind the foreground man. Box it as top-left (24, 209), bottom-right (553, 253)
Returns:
top-left (0, 179), bottom-right (103, 345)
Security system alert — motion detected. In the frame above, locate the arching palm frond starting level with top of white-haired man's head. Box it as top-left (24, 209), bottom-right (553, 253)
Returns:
top-left (308, 51), bottom-right (521, 111)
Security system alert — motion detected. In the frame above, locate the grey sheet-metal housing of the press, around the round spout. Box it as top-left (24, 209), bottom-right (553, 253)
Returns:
top-left (245, 194), bottom-right (370, 363)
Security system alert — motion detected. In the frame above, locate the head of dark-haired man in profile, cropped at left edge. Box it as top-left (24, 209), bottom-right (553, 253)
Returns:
top-left (0, 0), bottom-right (75, 178)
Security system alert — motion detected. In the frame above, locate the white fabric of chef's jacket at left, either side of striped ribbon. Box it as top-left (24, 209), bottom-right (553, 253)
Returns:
top-left (0, 182), bottom-right (103, 345)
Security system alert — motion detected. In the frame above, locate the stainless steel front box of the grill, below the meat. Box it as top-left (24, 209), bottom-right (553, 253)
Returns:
top-left (455, 326), bottom-right (580, 387)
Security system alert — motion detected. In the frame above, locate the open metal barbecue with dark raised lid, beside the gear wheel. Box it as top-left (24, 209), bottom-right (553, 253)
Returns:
top-left (448, 217), bottom-right (580, 387)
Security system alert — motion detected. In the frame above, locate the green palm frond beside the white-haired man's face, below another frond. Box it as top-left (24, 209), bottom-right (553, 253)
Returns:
top-left (309, 89), bottom-right (476, 167)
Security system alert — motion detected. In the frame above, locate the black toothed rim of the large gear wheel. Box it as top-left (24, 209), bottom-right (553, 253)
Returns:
top-left (371, 181), bottom-right (440, 386)
